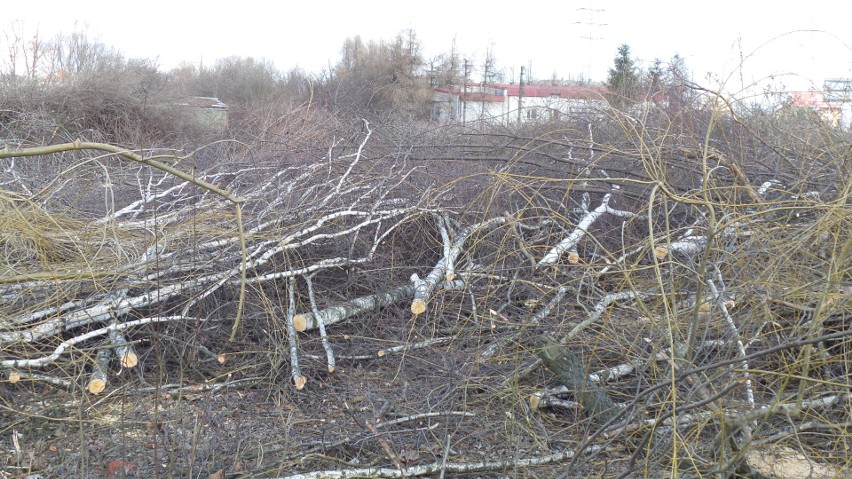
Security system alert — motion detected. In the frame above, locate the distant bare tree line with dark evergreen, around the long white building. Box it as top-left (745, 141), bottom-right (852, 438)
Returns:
top-left (0, 23), bottom-right (688, 142)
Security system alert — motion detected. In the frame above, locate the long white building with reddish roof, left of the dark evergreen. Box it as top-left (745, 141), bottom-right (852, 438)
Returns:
top-left (432, 84), bottom-right (607, 125)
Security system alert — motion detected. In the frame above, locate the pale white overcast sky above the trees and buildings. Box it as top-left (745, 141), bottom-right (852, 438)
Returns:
top-left (0, 0), bottom-right (852, 93)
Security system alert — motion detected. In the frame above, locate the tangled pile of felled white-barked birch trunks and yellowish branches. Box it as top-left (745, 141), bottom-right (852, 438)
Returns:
top-left (0, 106), bottom-right (852, 477)
